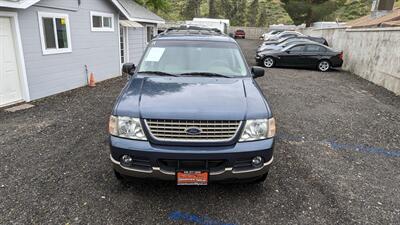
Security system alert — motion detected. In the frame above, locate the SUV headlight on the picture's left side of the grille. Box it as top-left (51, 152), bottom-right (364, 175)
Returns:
top-left (108, 116), bottom-right (147, 140)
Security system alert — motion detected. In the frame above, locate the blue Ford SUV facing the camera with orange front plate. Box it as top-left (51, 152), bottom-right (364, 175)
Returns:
top-left (109, 26), bottom-right (275, 185)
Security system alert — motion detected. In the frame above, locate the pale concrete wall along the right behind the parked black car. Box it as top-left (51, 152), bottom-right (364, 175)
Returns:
top-left (300, 28), bottom-right (400, 95)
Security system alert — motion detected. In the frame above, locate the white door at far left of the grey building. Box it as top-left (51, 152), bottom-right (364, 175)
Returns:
top-left (0, 17), bottom-right (22, 106)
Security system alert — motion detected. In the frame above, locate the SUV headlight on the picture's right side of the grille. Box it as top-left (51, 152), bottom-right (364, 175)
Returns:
top-left (239, 118), bottom-right (276, 142)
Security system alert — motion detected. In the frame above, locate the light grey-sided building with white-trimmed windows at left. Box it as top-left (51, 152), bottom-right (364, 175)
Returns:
top-left (0, 0), bottom-right (164, 106)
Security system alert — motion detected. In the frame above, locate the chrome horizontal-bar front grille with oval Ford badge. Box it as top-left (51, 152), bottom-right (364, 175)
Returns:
top-left (145, 119), bottom-right (241, 142)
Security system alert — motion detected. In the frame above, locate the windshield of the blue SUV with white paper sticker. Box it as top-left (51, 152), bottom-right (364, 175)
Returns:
top-left (138, 40), bottom-right (248, 77)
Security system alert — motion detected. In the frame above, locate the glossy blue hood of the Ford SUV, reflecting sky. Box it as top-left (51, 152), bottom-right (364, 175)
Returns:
top-left (113, 77), bottom-right (270, 120)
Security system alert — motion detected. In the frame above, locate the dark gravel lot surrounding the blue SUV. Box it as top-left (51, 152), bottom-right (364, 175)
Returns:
top-left (0, 40), bottom-right (400, 224)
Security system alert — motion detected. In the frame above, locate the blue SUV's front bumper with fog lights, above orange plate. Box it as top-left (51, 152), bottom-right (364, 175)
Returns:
top-left (110, 136), bottom-right (274, 182)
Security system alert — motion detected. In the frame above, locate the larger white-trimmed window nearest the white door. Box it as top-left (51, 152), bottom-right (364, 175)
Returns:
top-left (38, 12), bottom-right (72, 55)
